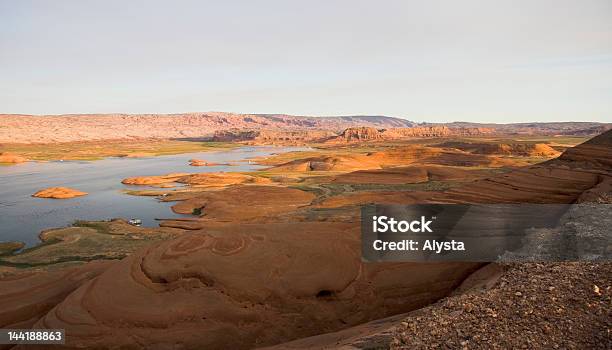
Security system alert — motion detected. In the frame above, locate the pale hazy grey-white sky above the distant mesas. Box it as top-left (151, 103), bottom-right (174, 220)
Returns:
top-left (0, 0), bottom-right (612, 123)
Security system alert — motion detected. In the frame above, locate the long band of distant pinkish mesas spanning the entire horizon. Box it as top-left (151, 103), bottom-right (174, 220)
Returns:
top-left (0, 112), bottom-right (612, 145)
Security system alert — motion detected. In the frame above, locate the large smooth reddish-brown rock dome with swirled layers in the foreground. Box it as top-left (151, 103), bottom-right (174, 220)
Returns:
top-left (35, 222), bottom-right (476, 349)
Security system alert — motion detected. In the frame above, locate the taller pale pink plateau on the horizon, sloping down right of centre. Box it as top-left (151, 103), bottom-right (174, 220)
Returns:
top-left (0, 112), bottom-right (414, 144)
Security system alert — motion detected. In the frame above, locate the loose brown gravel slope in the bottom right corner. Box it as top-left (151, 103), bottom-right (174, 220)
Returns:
top-left (391, 262), bottom-right (612, 349)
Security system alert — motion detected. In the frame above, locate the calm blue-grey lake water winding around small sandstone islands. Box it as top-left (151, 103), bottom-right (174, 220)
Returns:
top-left (0, 147), bottom-right (304, 246)
